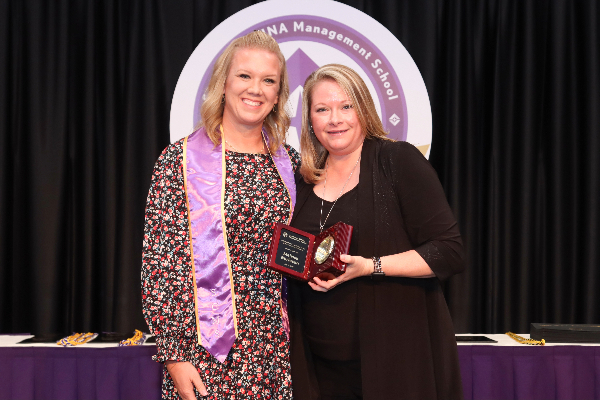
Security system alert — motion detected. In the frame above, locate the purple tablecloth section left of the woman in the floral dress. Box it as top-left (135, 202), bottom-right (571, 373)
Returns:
top-left (0, 346), bottom-right (162, 400)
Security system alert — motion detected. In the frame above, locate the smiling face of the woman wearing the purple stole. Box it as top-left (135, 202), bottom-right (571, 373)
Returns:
top-left (223, 48), bottom-right (281, 131)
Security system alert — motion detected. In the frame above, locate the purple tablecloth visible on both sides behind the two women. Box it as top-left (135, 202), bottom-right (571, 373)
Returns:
top-left (0, 345), bottom-right (600, 400)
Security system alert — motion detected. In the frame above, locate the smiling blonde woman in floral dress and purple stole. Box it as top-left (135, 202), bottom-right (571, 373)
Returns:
top-left (142, 31), bottom-right (299, 399)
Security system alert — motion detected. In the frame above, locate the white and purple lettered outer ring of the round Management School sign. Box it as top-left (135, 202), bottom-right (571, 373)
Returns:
top-left (170, 0), bottom-right (432, 157)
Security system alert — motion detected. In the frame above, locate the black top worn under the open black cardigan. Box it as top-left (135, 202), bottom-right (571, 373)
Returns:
top-left (294, 186), bottom-right (360, 360)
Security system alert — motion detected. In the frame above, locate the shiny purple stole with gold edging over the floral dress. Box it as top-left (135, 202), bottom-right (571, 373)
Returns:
top-left (183, 128), bottom-right (296, 362)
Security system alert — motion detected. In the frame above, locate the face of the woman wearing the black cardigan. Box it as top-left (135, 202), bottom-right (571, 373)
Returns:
top-left (310, 80), bottom-right (364, 155)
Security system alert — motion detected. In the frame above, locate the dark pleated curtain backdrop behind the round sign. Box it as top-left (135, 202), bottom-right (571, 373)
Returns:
top-left (0, 0), bottom-right (600, 333)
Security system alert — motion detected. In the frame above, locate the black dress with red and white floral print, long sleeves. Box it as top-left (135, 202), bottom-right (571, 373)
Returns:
top-left (142, 142), bottom-right (299, 399)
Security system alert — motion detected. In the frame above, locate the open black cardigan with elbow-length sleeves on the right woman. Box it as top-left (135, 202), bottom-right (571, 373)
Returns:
top-left (290, 139), bottom-right (464, 400)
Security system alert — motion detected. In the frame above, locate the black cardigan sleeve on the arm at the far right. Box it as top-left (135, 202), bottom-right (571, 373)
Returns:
top-left (381, 142), bottom-right (464, 280)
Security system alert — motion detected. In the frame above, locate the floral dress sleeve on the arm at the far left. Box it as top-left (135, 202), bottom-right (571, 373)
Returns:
top-left (142, 144), bottom-right (197, 362)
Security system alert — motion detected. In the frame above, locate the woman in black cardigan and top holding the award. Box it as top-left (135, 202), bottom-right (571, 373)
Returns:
top-left (290, 64), bottom-right (464, 400)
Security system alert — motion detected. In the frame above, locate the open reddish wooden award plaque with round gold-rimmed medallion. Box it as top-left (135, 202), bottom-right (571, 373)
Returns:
top-left (267, 222), bottom-right (353, 282)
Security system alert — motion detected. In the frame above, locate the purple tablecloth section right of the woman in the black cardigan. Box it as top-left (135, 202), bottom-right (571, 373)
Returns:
top-left (458, 346), bottom-right (600, 400)
